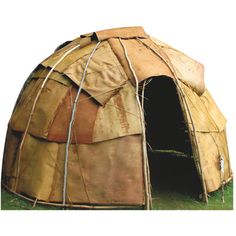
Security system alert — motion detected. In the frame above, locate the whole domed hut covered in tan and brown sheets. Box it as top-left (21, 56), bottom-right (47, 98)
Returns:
top-left (2, 27), bottom-right (232, 209)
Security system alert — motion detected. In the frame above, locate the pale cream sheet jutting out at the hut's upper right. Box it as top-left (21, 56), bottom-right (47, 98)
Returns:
top-left (146, 38), bottom-right (205, 95)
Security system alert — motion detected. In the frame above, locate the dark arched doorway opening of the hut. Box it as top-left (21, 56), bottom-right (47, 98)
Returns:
top-left (144, 76), bottom-right (201, 194)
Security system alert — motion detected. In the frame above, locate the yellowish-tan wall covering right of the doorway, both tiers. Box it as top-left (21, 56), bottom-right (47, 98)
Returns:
top-left (179, 82), bottom-right (232, 192)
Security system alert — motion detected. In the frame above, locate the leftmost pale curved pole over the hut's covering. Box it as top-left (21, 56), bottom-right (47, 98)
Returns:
top-left (15, 44), bottom-right (80, 191)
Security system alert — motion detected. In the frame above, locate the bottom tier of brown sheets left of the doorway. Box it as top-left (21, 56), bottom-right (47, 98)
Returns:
top-left (2, 128), bottom-right (144, 205)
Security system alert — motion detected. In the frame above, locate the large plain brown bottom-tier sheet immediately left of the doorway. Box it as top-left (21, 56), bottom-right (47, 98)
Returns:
top-left (68, 135), bottom-right (144, 205)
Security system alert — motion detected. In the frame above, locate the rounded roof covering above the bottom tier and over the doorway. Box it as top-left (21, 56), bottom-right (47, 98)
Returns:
top-left (9, 27), bottom-right (205, 143)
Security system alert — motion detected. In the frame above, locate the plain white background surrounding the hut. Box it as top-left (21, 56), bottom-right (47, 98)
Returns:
top-left (0, 0), bottom-right (236, 235)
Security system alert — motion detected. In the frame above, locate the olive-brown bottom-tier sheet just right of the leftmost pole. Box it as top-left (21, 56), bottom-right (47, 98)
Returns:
top-left (16, 135), bottom-right (58, 200)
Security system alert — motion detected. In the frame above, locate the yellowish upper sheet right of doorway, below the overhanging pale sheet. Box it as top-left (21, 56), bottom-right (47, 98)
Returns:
top-left (179, 81), bottom-right (226, 132)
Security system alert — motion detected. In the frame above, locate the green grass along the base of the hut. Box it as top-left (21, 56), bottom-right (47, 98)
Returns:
top-left (1, 182), bottom-right (233, 210)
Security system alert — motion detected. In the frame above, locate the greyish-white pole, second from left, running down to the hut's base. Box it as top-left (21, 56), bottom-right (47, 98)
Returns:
top-left (62, 42), bottom-right (101, 205)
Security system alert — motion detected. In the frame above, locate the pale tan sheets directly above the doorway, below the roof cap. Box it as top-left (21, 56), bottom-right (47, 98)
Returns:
top-left (108, 38), bottom-right (205, 95)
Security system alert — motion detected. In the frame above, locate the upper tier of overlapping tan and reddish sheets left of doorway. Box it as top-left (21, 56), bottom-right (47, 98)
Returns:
top-left (9, 42), bottom-right (141, 143)
